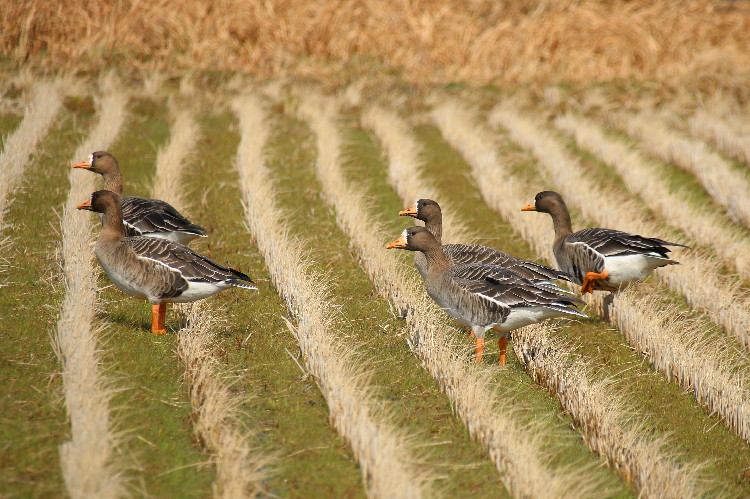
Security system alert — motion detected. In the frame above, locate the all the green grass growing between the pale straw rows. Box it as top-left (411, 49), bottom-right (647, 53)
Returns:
top-left (5, 76), bottom-right (750, 497)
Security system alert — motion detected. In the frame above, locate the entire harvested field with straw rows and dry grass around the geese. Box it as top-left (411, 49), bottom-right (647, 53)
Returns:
top-left (0, 0), bottom-right (750, 498)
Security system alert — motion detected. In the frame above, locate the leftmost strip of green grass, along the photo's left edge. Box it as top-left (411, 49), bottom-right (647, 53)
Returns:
top-left (0, 107), bottom-right (83, 497)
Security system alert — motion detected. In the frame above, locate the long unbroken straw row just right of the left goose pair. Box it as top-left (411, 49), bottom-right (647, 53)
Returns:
top-left (234, 95), bottom-right (433, 498)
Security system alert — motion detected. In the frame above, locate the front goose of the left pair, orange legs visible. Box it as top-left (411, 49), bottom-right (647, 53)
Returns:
top-left (77, 190), bottom-right (258, 334)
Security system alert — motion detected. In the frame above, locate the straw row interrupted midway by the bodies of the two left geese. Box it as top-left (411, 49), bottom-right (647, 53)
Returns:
top-left (151, 109), bottom-right (270, 498)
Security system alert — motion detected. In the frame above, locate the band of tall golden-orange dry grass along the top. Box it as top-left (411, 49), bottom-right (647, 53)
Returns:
top-left (5, 0), bottom-right (750, 92)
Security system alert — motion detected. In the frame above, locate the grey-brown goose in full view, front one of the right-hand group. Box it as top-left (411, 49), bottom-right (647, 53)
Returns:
top-left (386, 226), bottom-right (586, 365)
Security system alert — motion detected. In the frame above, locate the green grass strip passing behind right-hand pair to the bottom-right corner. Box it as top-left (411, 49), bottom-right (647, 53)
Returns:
top-left (418, 117), bottom-right (750, 495)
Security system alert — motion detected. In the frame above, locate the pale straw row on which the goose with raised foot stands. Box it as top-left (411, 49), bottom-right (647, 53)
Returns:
top-left (424, 98), bottom-right (745, 476)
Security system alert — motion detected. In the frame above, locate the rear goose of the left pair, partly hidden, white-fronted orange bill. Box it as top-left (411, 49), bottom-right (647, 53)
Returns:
top-left (73, 151), bottom-right (206, 244)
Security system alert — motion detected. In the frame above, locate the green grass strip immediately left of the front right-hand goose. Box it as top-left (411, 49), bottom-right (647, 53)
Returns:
top-left (269, 109), bottom-right (503, 496)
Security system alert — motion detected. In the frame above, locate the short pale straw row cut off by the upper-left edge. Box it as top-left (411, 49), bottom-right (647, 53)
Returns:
top-left (0, 79), bottom-right (64, 233)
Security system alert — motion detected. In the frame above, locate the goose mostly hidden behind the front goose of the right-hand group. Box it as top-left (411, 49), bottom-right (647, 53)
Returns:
top-left (398, 199), bottom-right (570, 283)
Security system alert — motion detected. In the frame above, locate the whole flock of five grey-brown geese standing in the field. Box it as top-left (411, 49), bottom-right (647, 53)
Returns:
top-left (73, 151), bottom-right (687, 365)
